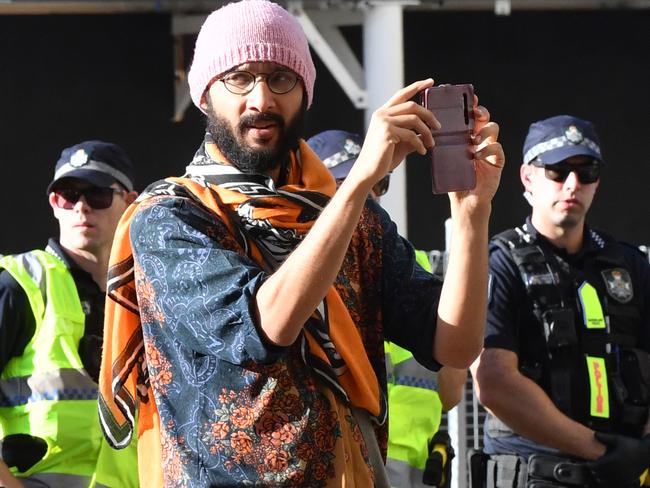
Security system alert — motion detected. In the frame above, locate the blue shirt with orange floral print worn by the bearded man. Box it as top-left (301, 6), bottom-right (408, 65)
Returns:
top-left (131, 193), bottom-right (441, 487)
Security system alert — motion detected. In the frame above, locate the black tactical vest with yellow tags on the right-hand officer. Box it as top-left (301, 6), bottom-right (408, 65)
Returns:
top-left (492, 226), bottom-right (650, 437)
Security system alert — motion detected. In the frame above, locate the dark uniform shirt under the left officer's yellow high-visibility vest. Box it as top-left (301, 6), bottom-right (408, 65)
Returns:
top-left (0, 239), bottom-right (106, 381)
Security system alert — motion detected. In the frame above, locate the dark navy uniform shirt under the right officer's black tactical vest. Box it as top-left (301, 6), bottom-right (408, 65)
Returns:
top-left (484, 218), bottom-right (650, 456)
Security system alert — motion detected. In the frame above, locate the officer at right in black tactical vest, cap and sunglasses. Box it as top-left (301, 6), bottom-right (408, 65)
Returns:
top-left (472, 115), bottom-right (650, 487)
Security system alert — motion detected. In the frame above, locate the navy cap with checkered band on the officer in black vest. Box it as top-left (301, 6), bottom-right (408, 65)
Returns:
top-left (523, 115), bottom-right (604, 165)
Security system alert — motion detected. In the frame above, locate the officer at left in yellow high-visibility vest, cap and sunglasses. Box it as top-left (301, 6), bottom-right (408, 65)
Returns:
top-left (0, 140), bottom-right (138, 488)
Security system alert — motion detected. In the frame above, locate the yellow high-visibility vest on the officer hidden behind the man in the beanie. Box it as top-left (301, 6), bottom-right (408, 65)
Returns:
top-left (384, 251), bottom-right (442, 488)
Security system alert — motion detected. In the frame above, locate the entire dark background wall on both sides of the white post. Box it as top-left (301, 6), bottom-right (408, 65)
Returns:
top-left (0, 10), bottom-right (650, 253)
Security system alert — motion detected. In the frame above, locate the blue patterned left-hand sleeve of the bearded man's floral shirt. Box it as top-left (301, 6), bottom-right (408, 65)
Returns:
top-left (131, 198), bottom-right (285, 364)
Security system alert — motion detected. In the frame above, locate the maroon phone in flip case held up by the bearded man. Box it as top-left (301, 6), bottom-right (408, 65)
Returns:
top-left (422, 85), bottom-right (476, 193)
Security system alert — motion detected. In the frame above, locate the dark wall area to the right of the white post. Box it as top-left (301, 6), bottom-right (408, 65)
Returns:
top-left (405, 10), bottom-right (650, 249)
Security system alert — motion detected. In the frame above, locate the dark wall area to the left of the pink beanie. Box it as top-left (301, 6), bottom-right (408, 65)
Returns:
top-left (0, 15), bottom-right (201, 252)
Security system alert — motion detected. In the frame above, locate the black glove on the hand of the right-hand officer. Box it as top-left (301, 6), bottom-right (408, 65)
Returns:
top-left (588, 432), bottom-right (650, 487)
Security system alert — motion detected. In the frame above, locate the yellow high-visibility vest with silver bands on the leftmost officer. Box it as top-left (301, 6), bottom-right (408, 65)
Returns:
top-left (0, 250), bottom-right (137, 487)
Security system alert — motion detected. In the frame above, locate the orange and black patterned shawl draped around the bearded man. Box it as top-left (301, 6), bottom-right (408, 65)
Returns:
top-left (99, 141), bottom-right (386, 486)
